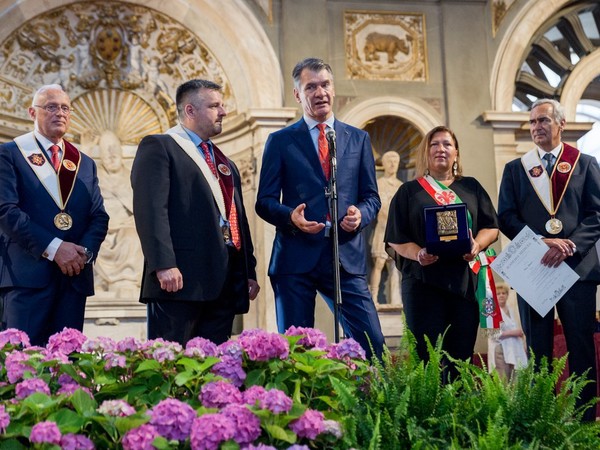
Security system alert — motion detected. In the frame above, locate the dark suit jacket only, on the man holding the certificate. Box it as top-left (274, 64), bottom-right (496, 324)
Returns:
top-left (498, 148), bottom-right (600, 282)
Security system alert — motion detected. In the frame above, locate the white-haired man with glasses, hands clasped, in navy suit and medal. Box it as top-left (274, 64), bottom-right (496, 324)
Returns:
top-left (0, 85), bottom-right (108, 345)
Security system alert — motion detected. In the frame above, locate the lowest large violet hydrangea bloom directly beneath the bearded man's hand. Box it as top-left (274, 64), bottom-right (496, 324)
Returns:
top-left (148, 398), bottom-right (196, 441)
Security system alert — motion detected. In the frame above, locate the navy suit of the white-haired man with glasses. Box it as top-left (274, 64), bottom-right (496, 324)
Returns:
top-left (0, 137), bottom-right (108, 345)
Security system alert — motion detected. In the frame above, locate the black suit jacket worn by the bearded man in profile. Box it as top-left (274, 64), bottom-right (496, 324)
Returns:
top-left (131, 126), bottom-right (256, 313)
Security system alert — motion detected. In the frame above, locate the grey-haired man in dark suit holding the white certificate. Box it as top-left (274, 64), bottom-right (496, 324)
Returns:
top-left (498, 99), bottom-right (600, 420)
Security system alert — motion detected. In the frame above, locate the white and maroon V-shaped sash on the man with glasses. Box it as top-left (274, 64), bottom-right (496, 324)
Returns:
top-left (14, 132), bottom-right (81, 211)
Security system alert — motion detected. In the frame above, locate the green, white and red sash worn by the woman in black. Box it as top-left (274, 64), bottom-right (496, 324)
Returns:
top-left (417, 175), bottom-right (502, 329)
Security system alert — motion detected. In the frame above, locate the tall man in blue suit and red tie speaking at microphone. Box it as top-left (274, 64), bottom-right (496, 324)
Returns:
top-left (256, 58), bottom-right (383, 355)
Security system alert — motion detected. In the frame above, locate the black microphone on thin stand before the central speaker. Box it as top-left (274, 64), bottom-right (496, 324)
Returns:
top-left (325, 130), bottom-right (342, 343)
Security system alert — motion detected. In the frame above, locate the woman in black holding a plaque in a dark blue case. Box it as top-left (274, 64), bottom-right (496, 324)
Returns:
top-left (385, 126), bottom-right (498, 376)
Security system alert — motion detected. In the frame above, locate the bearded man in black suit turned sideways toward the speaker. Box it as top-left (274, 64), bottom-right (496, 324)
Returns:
top-left (131, 80), bottom-right (259, 345)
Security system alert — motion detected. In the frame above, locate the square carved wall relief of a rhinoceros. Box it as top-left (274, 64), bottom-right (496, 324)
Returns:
top-left (344, 11), bottom-right (428, 81)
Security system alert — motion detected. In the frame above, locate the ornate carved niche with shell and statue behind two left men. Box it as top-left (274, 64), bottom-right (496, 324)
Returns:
top-left (0, 1), bottom-right (239, 300)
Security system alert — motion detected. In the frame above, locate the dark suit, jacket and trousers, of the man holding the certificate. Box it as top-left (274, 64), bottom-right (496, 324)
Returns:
top-left (498, 149), bottom-right (600, 419)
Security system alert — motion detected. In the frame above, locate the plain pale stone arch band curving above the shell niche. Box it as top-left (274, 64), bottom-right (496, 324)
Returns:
top-left (0, 0), bottom-right (283, 117)
